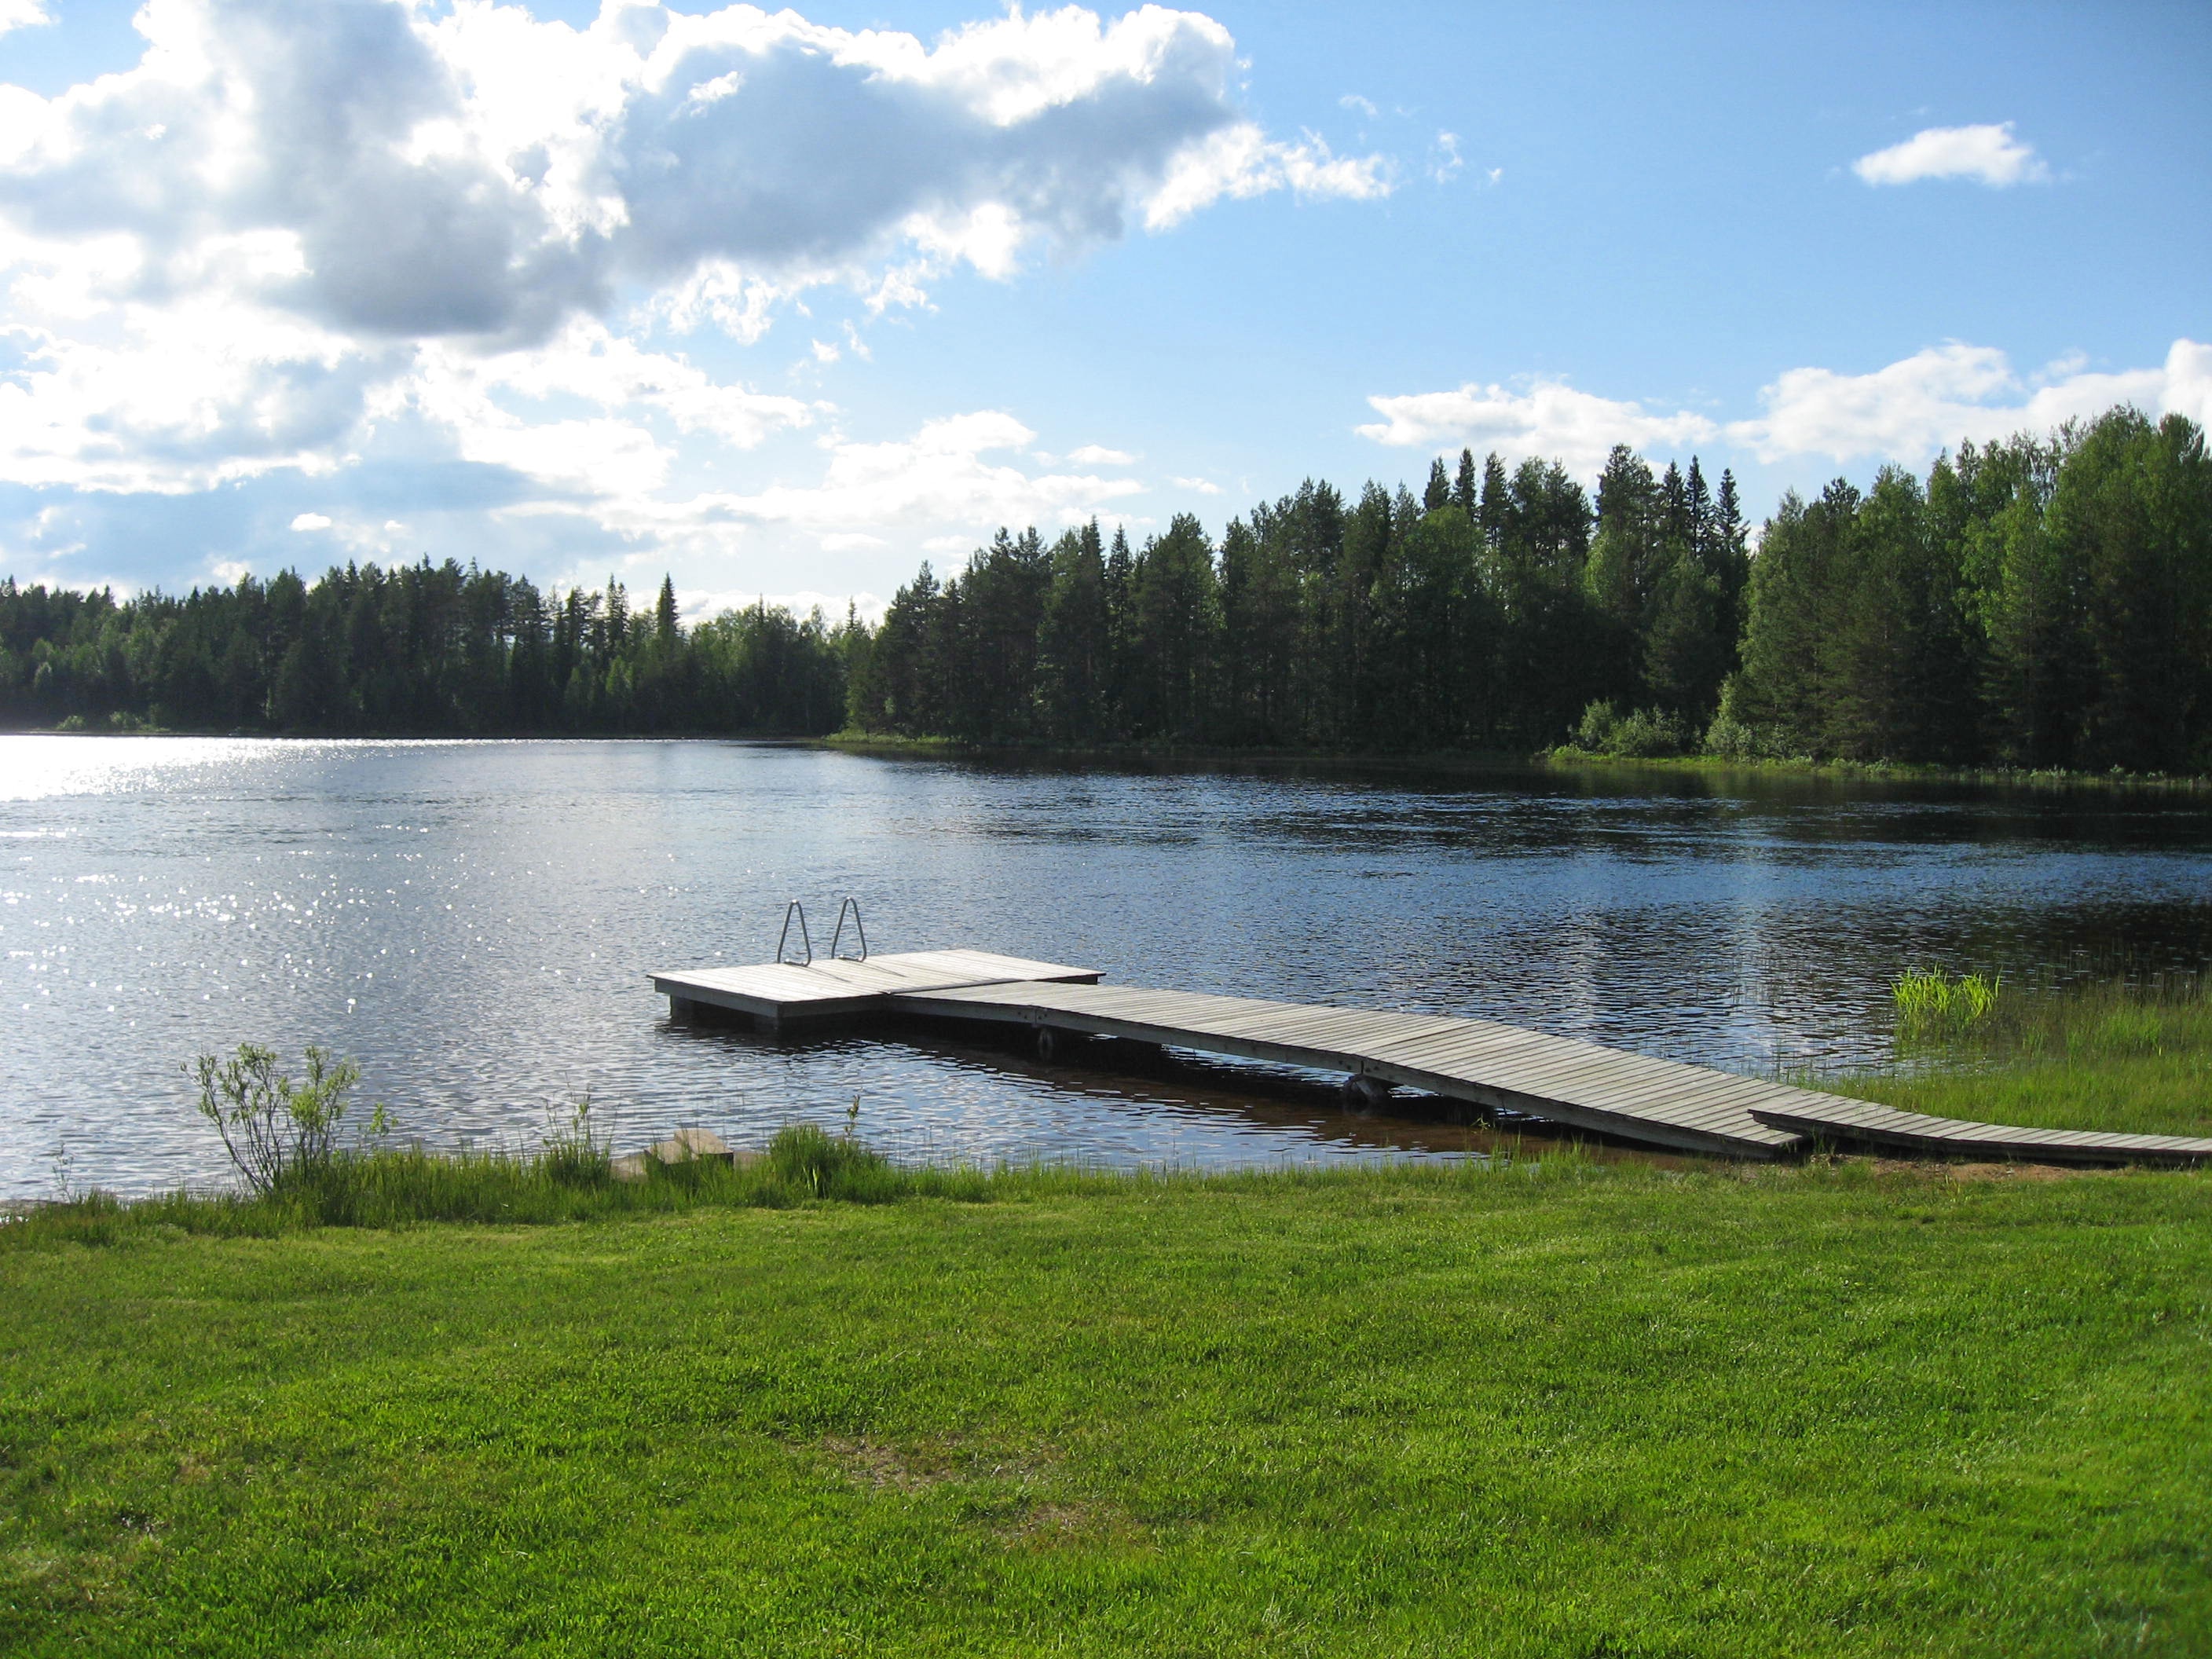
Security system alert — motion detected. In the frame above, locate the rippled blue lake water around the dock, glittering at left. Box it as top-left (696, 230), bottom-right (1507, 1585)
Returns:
top-left (0, 737), bottom-right (2212, 1196)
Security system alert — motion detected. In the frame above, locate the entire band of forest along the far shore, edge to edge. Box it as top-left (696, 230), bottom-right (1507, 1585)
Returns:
top-left (0, 407), bottom-right (2212, 772)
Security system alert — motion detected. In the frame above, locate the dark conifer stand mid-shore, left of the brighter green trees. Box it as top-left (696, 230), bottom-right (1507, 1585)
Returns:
top-left (849, 449), bottom-right (1749, 750)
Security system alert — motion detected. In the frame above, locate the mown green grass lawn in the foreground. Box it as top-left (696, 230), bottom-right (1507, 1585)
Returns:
top-left (0, 1159), bottom-right (2212, 1657)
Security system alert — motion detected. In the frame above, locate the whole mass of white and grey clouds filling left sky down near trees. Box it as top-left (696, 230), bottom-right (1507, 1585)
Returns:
top-left (0, 0), bottom-right (1391, 566)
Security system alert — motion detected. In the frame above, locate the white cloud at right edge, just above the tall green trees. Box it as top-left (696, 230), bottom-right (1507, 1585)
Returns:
top-left (1727, 339), bottom-right (2212, 463)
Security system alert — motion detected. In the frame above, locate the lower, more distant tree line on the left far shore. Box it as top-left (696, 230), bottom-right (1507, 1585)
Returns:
top-left (0, 558), bottom-right (862, 734)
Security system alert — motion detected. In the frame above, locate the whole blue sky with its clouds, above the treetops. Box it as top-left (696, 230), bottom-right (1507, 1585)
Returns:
top-left (0, 0), bottom-right (2212, 610)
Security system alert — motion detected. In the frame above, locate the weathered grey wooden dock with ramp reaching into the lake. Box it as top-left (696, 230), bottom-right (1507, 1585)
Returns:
top-left (650, 951), bottom-right (2212, 1163)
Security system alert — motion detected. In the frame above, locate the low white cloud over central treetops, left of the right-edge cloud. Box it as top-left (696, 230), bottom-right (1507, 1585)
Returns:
top-left (1358, 380), bottom-right (1719, 475)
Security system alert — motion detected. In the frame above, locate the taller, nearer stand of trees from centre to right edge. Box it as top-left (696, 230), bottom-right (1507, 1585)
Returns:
top-left (849, 407), bottom-right (2212, 772)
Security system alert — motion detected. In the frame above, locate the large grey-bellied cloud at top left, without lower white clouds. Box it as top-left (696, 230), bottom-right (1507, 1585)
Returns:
top-left (0, 0), bottom-right (1387, 341)
